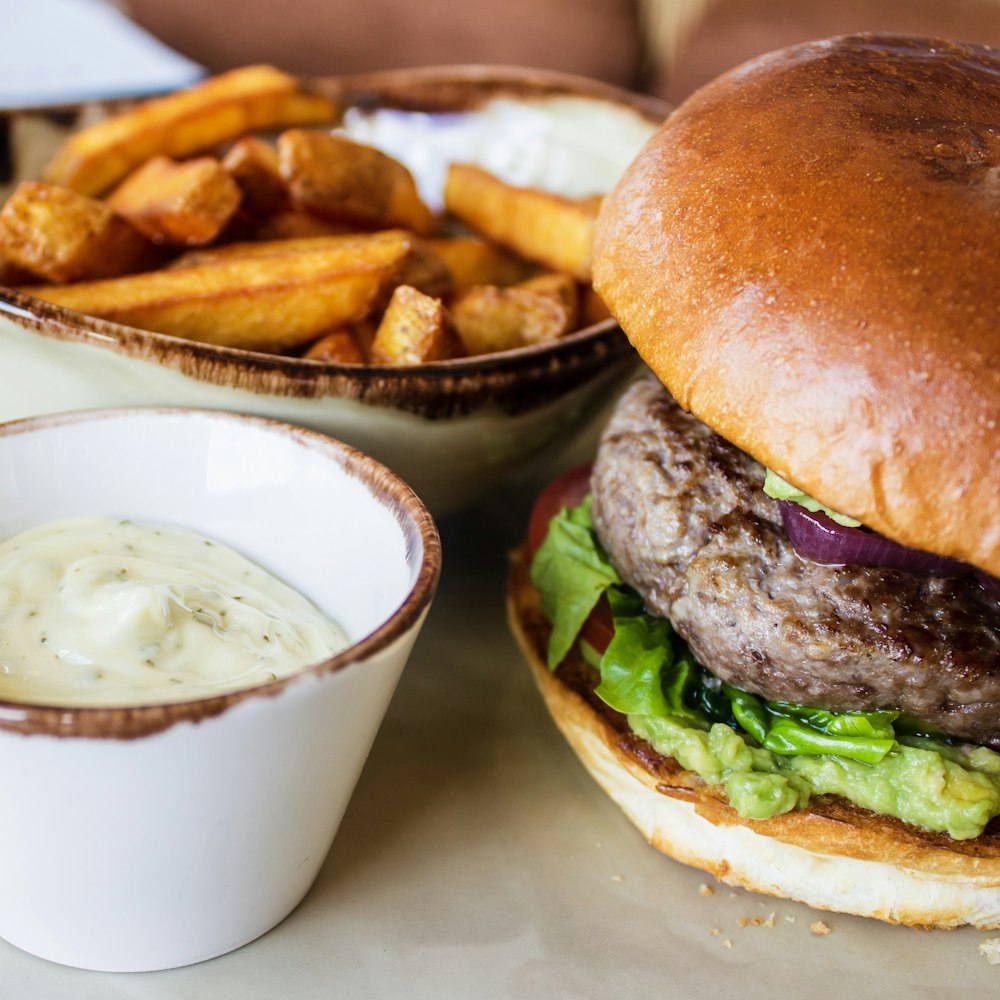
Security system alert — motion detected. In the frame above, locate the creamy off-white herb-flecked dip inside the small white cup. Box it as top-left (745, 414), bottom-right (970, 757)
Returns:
top-left (0, 517), bottom-right (348, 706)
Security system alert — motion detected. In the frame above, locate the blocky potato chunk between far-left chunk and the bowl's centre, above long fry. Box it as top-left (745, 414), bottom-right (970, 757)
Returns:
top-left (107, 156), bottom-right (241, 246)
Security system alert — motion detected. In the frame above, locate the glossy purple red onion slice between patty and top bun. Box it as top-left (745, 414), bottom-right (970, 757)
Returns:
top-left (778, 500), bottom-right (970, 576)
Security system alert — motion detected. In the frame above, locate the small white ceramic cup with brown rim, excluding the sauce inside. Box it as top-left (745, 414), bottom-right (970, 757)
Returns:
top-left (0, 409), bottom-right (441, 971)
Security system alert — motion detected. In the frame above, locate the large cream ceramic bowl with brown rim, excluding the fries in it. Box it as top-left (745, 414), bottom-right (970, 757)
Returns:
top-left (0, 67), bottom-right (665, 515)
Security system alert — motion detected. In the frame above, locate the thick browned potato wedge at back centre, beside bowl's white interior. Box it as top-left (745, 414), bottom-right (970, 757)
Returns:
top-left (278, 129), bottom-right (435, 236)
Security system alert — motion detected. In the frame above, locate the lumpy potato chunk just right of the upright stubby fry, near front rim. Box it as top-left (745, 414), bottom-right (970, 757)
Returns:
top-left (451, 285), bottom-right (572, 354)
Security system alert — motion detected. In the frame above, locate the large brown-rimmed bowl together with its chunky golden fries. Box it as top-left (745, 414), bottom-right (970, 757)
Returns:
top-left (0, 66), bottom-right (665, 515)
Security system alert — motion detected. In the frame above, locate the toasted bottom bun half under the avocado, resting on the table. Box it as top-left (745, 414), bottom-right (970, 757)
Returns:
top-left (507, 550), bottom-right (1000, 930)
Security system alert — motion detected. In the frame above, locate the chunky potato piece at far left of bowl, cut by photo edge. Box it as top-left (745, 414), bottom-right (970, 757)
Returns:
top-left (0, 181), bottom-right (154, 281)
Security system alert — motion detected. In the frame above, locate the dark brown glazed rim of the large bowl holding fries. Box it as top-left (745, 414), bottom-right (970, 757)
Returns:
top-left (0, 64), bottom-right (670, 398)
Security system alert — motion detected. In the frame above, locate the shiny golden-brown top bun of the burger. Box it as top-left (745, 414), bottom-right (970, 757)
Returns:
top-left (594, 35), bottom-right (1000, 576)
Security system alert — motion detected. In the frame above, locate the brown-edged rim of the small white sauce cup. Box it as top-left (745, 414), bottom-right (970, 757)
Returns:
top-left (0, 406), bottom-right (442, 740)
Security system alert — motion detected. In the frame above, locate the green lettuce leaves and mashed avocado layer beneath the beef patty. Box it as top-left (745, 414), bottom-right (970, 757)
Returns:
top-left (532, 497), bottom-right (1000, 840)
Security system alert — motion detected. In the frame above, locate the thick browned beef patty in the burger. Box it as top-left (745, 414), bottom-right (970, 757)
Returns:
top-left (591, 379), bottom-right (1000, 747)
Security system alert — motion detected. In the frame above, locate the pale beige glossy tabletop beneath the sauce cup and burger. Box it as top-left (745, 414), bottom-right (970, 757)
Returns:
top-left (0, 474), bottom-right (1000, 1000)
